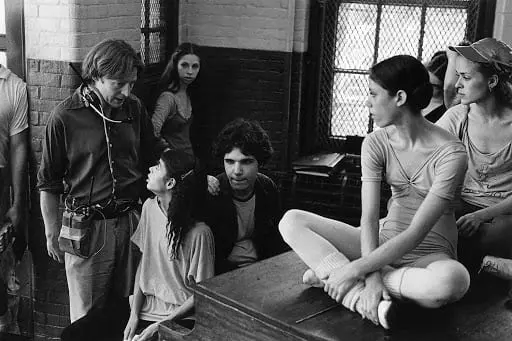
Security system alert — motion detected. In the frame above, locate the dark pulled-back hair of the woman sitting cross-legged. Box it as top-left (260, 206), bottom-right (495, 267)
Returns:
top-left (370, 55), bottom-right (432, 113)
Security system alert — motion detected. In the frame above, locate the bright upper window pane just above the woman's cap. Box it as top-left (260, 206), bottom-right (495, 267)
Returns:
top-left (423, 8), bottom-right (468, 61)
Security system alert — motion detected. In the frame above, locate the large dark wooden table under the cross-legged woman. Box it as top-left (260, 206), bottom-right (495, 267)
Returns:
top-left (159, 252), bottom-right (512, 341)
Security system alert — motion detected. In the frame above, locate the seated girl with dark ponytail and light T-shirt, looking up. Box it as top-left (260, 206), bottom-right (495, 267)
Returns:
top-left (124, 149), bottom-right (215, 341)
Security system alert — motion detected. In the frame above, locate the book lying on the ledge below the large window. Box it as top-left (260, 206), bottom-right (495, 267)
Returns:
top-left (292, 153), bottom-right (345, 177)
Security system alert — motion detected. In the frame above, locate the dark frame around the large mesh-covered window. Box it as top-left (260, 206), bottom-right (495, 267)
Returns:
top-left (300, 0), bottom-right (496, 154)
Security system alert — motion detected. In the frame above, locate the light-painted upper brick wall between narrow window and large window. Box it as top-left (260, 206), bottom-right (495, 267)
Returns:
top-left (180, 0), bottom-right (295, 52)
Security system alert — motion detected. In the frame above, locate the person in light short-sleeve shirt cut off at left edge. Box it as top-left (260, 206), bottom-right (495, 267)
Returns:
top-left (0, 64), bottom-right (28, 333)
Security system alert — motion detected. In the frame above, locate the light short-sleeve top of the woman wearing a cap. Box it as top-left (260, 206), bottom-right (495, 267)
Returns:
top-left (437, 105), bottom-right (512, 207)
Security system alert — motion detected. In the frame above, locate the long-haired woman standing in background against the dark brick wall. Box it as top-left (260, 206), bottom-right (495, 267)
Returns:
top-left (151, 43), bottom-right (201, 167)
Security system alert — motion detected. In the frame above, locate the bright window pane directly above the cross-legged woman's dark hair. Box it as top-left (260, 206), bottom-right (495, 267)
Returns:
top-left (378, 6), bottom-right (421, 61)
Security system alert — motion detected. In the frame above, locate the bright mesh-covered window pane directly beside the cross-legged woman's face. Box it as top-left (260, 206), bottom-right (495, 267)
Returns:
top-left (330, 73), bottom-right (368, 136)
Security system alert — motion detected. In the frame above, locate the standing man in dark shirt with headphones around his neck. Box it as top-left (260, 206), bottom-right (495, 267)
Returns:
top-left (38, 40), bottom-right (158, 322)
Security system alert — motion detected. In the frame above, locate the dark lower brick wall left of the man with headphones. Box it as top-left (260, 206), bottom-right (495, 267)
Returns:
top-left (27, 59), bottom-right (79, 340)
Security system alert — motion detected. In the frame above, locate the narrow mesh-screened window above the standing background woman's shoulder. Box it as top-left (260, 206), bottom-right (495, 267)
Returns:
top-left (140, 0), bottom-right (167, 65)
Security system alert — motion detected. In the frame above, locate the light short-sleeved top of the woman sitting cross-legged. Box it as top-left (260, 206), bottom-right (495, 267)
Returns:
top-left (361, 128), bottom-right (467, 265)
